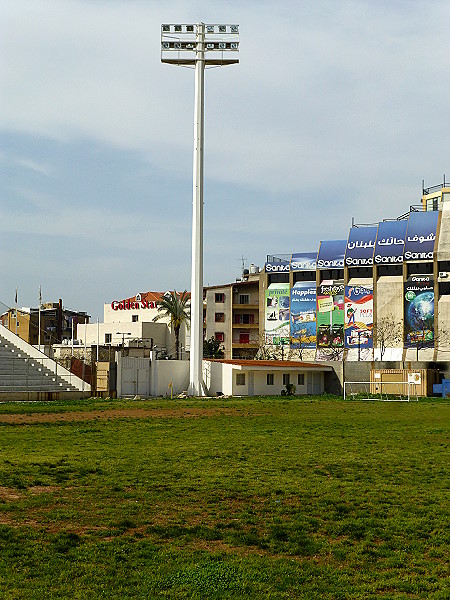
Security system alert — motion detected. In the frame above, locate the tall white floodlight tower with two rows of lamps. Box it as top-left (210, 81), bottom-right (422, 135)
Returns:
top-left (161, 23), bottom-right (239, 396)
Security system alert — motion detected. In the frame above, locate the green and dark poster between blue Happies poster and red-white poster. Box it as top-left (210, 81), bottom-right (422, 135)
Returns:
top-left (316, 282), bottom-right (345, 348)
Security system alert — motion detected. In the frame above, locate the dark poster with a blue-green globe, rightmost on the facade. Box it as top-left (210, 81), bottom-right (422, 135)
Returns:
top-left (404, 275), bottom-right (434, 348)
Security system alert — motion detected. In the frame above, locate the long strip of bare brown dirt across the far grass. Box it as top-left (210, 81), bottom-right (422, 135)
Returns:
top-left (0, 407), bottom-right (256, 425)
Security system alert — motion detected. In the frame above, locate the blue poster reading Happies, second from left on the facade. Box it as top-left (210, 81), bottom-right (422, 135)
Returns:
top-left (291, 281), bottom-right (316, 348)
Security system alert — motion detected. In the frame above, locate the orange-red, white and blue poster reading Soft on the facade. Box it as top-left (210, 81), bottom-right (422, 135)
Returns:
top-left (345, 284), bottom-right (373, 351)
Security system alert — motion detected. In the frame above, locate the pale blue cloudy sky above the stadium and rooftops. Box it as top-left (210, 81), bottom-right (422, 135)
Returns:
top-left (0, 0), bottom-right (450, 319)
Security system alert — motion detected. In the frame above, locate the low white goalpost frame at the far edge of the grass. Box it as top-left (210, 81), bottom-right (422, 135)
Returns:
top-left (344, 381), bottom-right (419, 402)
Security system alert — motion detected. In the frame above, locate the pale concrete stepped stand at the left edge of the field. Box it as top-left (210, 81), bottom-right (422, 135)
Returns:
top-left (0, 325), bottom-right (91, 399)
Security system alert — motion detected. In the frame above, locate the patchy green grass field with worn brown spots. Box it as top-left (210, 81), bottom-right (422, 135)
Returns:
top-left (0, 398), bottom-right (450, 600)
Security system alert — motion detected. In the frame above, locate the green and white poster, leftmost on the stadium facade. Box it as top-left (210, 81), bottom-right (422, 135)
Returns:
top-left (265, 283), bottom-right (290, 346)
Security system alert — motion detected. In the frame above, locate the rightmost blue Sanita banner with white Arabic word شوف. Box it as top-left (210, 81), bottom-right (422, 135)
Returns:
top-left (403, 210), bottom-right (439, 261)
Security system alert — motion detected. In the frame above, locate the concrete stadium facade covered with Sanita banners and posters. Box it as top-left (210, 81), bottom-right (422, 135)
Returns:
top-left (259, 182), bottom-right (450, 363)
